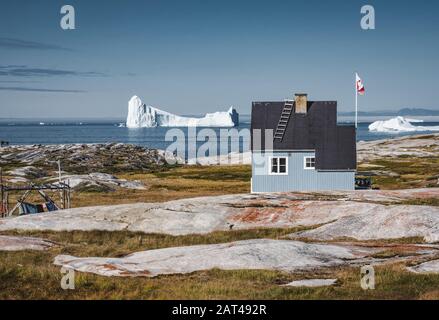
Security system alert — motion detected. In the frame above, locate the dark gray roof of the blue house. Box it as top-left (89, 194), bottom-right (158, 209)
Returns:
top-left (251, 101), bottom-right (357, 170)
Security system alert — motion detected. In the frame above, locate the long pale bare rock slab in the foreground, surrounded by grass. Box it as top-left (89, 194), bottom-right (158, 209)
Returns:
top-left (54, 239), bottom-right (373, 277)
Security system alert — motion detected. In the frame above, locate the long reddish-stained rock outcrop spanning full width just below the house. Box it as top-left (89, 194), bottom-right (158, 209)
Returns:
top-left (0, 188), bottom-right (439, 242)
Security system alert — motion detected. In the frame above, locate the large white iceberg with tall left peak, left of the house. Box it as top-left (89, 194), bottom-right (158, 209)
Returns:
top-left (126, 96), bottom-right (239, 128)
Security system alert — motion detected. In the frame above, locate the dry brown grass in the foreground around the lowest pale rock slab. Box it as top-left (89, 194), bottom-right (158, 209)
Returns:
top-left (0, 229), bottom-right (439, 300)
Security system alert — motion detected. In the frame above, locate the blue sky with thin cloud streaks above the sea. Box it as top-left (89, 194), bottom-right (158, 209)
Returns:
top-left (0, 0), bottom-right (439, 118)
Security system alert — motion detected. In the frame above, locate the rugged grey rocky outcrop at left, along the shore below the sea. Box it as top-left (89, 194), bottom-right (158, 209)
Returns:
top-left (0, 143), bottom-right (184, 177)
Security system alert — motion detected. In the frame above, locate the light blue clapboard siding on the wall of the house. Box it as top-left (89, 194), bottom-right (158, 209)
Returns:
top-left (252, 151), bottom-right (355, 192)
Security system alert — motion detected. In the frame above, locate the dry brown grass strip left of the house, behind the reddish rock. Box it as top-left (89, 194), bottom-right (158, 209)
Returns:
top-left (3, 165), bottom-right (251, 207)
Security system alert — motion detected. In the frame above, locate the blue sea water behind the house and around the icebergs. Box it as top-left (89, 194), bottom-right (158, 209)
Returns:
top-left (0, 115), bottom-right (439, 159)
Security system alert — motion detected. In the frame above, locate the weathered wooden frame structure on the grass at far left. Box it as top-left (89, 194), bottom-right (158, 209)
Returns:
top-left (0, 168), bottom-right (71, 218)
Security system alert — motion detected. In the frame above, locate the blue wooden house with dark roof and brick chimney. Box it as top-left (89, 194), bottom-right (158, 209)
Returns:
top-left (251, 94), bottom-right (357, 192)
